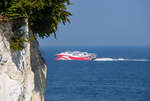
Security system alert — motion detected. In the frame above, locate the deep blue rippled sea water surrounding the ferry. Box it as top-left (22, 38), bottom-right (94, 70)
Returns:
top-left (40, 47), bottom-right (150, 101)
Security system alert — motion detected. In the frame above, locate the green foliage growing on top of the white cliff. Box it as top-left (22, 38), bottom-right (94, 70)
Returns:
top-left (0, 0), bottom-right (71, 50)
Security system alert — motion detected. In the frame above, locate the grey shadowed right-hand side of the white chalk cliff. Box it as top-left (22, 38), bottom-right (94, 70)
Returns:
top-left (30, 40), bottom-right (46, 96)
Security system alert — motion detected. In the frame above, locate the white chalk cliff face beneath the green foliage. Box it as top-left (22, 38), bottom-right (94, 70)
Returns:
top-left (0, 19), bottom-right (46, 101)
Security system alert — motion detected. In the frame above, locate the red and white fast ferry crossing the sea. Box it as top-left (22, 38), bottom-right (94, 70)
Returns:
top-left (56, 51), bottom-right (96, 60)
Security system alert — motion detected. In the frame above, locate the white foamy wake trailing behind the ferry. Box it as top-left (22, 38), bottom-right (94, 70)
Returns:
top-left (94, 58), bottom-right (150, 61)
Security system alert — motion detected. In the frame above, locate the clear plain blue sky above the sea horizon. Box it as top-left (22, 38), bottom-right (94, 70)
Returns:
top-left (39, 0), bottom-right (150, 46)
